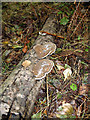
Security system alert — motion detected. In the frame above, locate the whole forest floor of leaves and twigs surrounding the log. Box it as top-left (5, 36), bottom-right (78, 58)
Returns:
top-left (0, 3), bottom-right (90, 118)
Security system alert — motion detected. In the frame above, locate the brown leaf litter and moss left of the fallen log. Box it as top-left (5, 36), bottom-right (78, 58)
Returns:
top-left (1, 2), bottom-right (52, 82)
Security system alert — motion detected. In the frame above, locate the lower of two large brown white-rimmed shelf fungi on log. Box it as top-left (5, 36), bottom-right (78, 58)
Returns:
top-left (32, 59), bottom-right (54, 80)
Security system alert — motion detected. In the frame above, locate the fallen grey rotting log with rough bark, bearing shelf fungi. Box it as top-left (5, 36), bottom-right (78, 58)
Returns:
top-left (0, 14), bottom-right (57, 118)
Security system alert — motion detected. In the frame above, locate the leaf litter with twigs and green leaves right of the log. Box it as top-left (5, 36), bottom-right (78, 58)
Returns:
top-left (31, 4), bottom-right (89, 118)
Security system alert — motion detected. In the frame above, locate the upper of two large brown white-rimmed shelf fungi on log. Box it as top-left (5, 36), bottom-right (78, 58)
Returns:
top-left (33, 42), bottom-right (56, 59)
